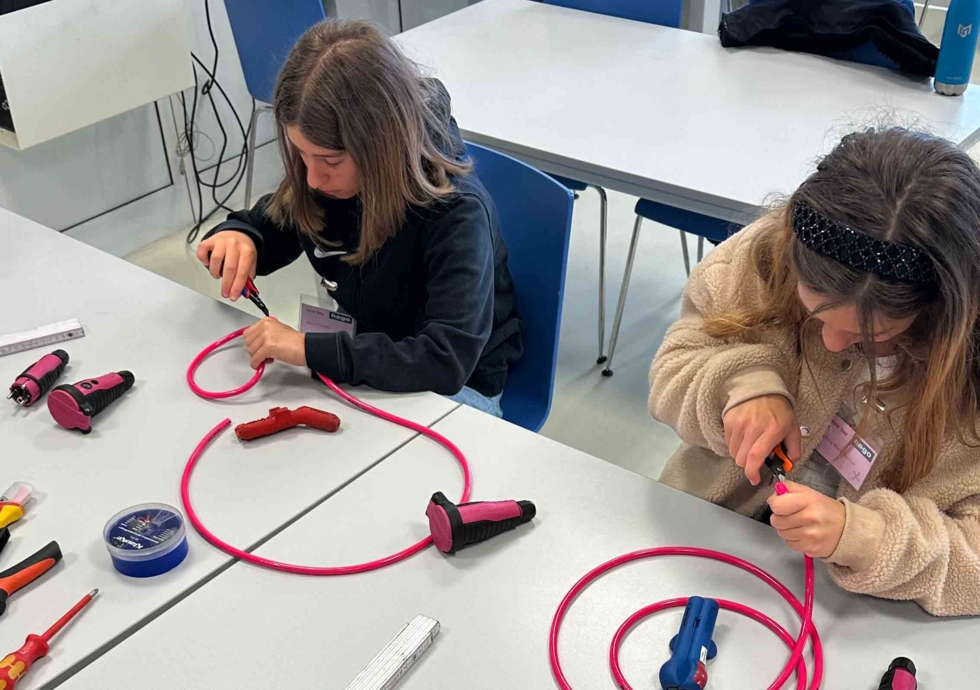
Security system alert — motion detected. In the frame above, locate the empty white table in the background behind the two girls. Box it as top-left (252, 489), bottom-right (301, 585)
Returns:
top-left (397, 0), bottom-right (980, 222)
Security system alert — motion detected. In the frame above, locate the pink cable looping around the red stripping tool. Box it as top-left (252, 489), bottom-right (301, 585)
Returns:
top-left (180, 328), bottom-right (473, 576)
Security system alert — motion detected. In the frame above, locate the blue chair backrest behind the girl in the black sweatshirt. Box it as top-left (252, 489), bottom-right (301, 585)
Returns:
top-left (466, 143), bottom-right (572, 431)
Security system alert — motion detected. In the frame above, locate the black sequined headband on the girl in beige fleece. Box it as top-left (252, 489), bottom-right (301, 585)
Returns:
top-left (793, 201), bottom-right (938, 283)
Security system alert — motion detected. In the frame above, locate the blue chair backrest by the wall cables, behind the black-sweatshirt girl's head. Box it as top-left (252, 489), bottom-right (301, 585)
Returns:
top-left (225, 0), bottom-right (326, 103)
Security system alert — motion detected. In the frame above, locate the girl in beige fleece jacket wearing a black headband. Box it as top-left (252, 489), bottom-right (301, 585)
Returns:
top-left (649, 129), bottom-right (980, 616)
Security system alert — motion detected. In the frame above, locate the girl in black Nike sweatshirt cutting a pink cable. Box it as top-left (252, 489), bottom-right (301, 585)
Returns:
top-left (197, 21), bottom-right (523, 416)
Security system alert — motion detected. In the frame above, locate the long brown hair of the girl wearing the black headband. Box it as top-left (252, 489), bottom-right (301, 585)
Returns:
top-left (706, 128), bottom-right (980, 492)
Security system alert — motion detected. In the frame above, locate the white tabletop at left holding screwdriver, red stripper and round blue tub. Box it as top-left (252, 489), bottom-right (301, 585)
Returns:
top-left (0, 210), bottom-right (456, 688)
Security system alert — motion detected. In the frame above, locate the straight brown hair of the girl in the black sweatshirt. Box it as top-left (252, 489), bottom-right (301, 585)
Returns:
top-left (266, 21), bottom-right (470, 264)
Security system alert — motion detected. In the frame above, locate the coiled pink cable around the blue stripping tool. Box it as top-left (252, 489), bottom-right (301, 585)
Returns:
top-left (548, 546), bottom-right (823, 690)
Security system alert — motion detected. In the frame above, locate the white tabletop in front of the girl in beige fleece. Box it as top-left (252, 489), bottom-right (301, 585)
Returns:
top-left (65, 407), bottom-right (980, 690)
